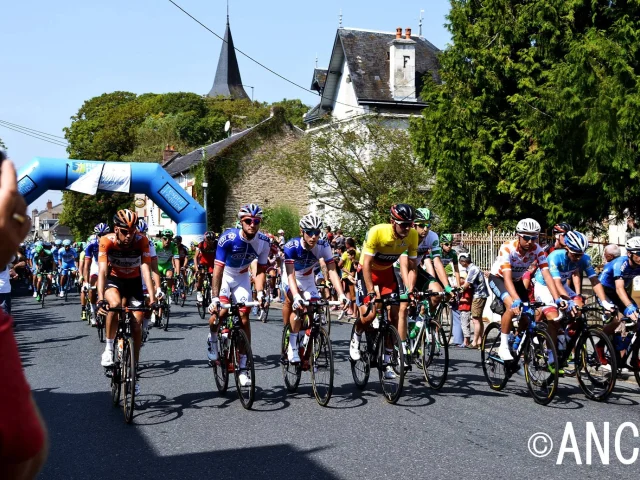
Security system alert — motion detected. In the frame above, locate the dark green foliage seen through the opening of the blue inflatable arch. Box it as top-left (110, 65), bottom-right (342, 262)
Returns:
top-left (60, 192), bottom-right (133, 239)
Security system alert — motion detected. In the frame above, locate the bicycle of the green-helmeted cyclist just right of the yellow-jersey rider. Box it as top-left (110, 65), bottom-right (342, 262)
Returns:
top-left (405, 291), bottom-right (449, 390)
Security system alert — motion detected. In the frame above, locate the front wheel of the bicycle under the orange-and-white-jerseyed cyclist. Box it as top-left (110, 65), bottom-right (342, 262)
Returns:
top-left (523, 330), bottom-right (559, 405)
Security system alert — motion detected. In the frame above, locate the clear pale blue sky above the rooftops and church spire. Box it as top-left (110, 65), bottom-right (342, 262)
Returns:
top-left (0, 0), bottom-right (450, 208)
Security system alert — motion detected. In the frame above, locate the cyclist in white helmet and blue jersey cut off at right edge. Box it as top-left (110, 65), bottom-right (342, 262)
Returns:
top-left (600, 237), bottom-right (640, 335)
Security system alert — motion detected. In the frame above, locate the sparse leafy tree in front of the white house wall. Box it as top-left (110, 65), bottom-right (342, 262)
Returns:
top-left (282, 117), bottom-right (430, 236)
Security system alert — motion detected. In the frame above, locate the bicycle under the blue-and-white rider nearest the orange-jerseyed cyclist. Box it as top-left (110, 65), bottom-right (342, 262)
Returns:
top-left (209, 302), bottom-right (259, 410)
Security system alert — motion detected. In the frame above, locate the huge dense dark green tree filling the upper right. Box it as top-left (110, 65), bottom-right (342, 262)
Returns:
top-left (411, 0), bottom-right (640, 229)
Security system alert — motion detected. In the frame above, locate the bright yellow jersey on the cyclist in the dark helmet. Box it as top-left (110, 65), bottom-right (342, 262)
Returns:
top-left (360, 223), bottom-right (418, 270)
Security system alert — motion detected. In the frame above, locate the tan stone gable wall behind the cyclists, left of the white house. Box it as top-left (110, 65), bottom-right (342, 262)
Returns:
top-left (224, 125), bottom-right (309, 227)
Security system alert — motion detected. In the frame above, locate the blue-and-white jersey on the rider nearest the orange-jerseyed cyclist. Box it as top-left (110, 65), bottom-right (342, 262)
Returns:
top-left (215, 228), bottom-right (270, 274)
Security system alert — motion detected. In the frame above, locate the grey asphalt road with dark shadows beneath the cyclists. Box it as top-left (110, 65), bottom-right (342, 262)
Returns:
top-left (14, 286), bottom-right (640, 480)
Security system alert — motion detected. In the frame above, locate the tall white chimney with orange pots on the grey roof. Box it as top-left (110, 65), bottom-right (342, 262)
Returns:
top-left (389, 27), bottom-right (417, 102)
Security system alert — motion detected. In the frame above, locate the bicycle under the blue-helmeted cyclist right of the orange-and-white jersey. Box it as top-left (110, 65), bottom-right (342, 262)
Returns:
top-left (556, 305), bottom-right (617, 402)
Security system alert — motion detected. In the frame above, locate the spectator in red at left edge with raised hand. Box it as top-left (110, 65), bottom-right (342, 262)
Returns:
top-left (0, 156), bottom-right (48, 479)
